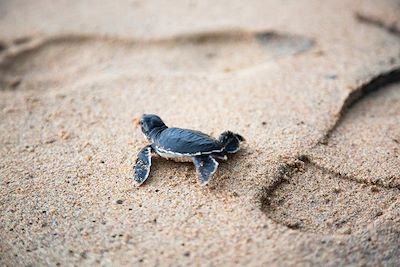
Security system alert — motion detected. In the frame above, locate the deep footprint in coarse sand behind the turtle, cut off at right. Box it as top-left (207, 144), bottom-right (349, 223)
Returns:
top-left (262, 72), bottom-right (400, 234)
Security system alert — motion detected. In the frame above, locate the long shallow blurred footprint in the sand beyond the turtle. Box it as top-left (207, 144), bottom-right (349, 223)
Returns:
top-left (0, 31), bottom-right (313, 89)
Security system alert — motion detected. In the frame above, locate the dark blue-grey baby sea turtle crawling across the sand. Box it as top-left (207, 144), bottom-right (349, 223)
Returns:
top-left (133, 114), bottom-right (244, 185)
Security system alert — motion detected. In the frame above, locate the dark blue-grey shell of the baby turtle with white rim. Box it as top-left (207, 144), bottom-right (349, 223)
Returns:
top-left (153, 128), bottom-right (223, 156)
